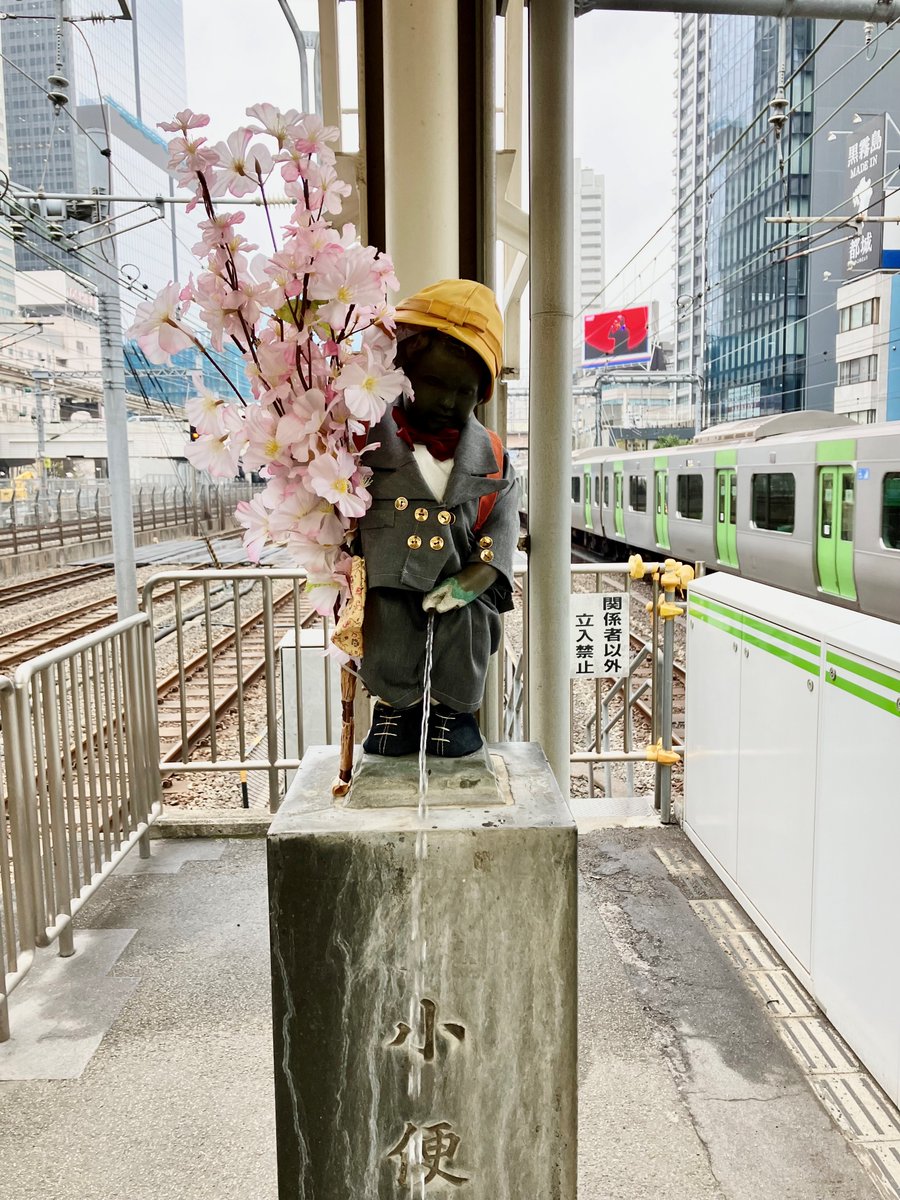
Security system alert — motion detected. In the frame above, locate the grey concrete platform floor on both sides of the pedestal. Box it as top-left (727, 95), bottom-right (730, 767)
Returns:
top-left (0, 827), bottom-right (889, 1200)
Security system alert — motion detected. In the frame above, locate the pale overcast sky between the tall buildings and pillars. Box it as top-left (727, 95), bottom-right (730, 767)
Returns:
top-left (184, 0), bottom-right (676, 324)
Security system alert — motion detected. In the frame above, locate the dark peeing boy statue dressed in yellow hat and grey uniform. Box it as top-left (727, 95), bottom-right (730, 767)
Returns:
top-left (359, 280), bottom-right (518, 758)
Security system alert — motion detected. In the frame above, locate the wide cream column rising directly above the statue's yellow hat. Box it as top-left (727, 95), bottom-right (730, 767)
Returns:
top-left (383, 0), bottom-right (460, 296)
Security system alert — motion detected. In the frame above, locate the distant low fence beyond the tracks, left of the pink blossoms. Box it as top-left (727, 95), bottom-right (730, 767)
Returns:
top-left (0, 482), bottom-right (258, 553)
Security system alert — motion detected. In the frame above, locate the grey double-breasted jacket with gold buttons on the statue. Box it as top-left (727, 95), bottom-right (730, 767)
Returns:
top-left (359, 412), bottom-right (518, 592)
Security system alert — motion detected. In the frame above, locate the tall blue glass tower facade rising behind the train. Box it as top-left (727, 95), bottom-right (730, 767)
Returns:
top-left (703, 17), bottom-right (815, 425)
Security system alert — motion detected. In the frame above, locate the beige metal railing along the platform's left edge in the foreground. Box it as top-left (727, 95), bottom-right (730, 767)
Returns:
top-left (0, 614), bottom-right (162, 1040)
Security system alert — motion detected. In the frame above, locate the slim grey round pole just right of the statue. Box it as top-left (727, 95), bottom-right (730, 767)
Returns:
top-left (528, 0), bottom-right (575, 794)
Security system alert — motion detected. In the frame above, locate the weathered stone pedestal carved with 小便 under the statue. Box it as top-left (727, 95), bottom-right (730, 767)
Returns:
top-left (269, 743), bottom-right (577, 1200)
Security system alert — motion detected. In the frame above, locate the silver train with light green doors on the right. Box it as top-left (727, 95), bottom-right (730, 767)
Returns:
top-left (571, 413), bottom-right (900, 622)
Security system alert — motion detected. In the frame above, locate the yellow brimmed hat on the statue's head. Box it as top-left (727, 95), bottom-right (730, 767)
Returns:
top-left (397, 280), bottom-right (503, 400)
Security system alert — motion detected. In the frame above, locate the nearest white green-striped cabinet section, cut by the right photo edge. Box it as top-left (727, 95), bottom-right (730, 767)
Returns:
top-left (812, 638), bottom-right (900, 1100)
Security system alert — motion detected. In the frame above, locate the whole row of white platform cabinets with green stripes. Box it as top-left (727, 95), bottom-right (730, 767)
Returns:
top-left (684, 575), bottom-right (900, 1103)
